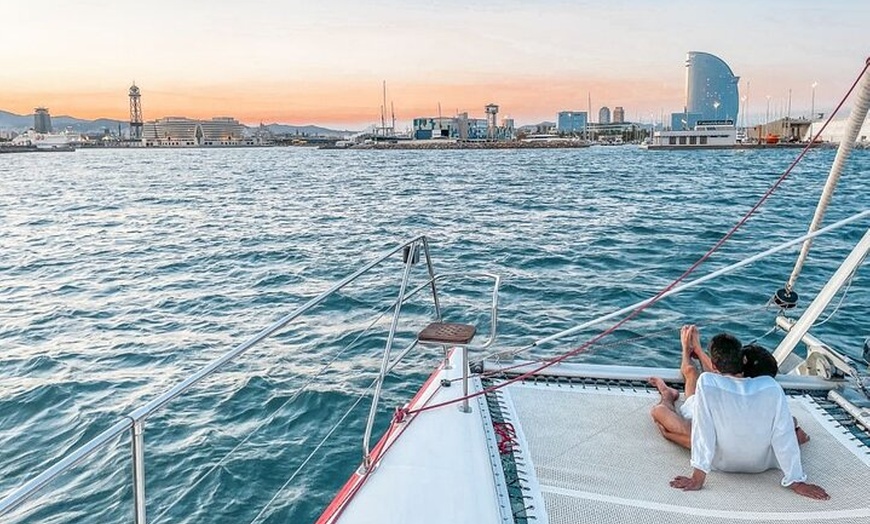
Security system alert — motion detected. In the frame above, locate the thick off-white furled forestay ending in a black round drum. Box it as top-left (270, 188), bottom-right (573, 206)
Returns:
top-left (775, 58), bottom-right (870, 307)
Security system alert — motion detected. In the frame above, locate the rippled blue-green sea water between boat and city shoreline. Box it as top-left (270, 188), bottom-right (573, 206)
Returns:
top-left (0, 146), bottom-right (870, 523)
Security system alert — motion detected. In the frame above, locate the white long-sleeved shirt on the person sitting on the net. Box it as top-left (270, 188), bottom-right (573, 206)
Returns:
top-left (692, 373), bottom-right (806, 486)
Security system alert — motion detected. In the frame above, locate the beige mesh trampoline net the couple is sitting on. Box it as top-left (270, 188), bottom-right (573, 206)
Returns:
top-left (506, 383), bottom-right (870, 524)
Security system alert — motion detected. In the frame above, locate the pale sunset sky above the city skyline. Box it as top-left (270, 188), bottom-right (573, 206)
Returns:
top-left (0, 0), bottom-right (870, 128)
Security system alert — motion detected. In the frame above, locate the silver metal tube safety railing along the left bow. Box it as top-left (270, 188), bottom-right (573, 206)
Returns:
top-left (0, 235), bottom-right (497, 524)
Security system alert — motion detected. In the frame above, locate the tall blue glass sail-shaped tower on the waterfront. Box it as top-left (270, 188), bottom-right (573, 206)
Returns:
top-left (685, 51), bottom-right (740, 122)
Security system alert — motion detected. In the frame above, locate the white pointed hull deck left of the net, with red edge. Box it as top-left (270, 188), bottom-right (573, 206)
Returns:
top-left (337, 351), bottom-right (507, 524)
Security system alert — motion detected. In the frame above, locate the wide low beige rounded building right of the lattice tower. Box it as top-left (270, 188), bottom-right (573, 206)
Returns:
top-left (143, 116), bottom-right (259, 147)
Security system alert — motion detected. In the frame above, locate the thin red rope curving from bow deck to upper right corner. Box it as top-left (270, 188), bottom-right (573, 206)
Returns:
top-left (408, 59), bottom-right (870, 414)
